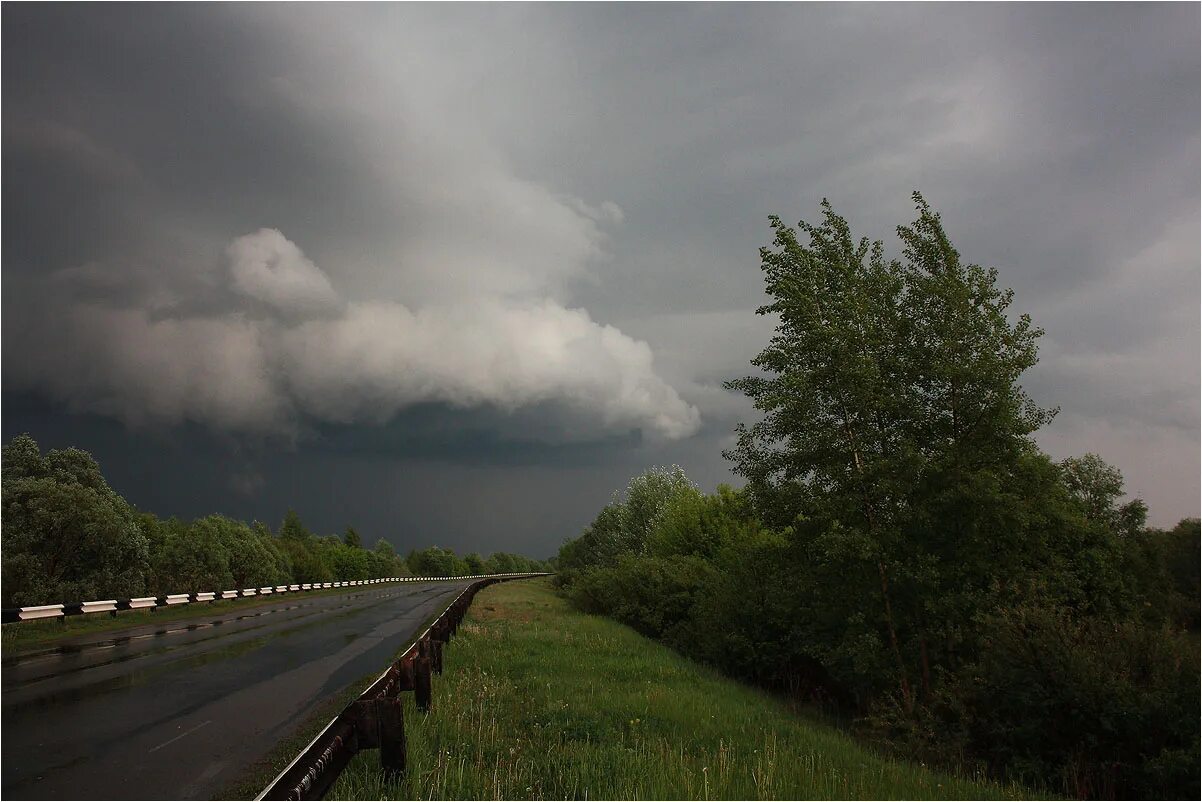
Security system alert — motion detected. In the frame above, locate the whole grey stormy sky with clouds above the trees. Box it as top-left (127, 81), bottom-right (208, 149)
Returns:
top-left (2, 4), bottom-right (1200, 556)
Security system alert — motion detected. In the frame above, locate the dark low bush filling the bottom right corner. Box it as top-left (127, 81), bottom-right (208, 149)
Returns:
top-left (908, 607), bottom-right (1200, 798)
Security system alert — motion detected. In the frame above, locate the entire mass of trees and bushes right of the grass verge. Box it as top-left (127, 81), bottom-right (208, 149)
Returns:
top-left (558, 196), bottom-right (1200, 798)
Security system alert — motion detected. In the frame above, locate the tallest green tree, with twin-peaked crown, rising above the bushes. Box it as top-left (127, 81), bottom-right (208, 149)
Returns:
top-left (727, 194), bottom-right (1053, 708)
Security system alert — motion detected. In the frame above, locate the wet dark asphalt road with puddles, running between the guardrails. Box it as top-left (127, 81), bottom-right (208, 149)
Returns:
top-left (0, 581), bottom-right (469, 800)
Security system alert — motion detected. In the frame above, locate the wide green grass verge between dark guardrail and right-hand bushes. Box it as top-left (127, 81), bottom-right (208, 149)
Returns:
top-left (327, 580), bottom-right (1031, 800)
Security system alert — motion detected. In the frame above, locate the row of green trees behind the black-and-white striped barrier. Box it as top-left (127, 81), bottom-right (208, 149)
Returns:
top-left (0, 434), bottom-right (545, 607)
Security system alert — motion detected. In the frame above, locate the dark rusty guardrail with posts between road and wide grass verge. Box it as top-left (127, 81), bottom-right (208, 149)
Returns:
top-left (255, 574), bottom-right (548, 802)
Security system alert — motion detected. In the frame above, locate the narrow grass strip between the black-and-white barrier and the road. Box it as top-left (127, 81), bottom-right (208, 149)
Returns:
top-left (0, 583), bottom-right (418, 649)
